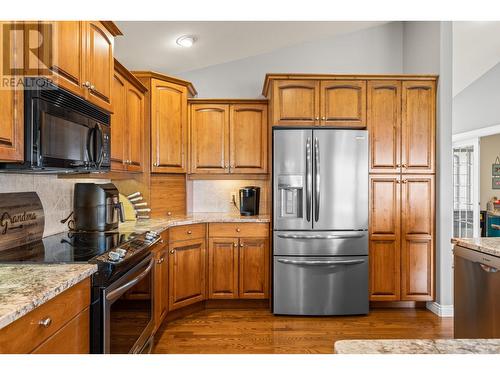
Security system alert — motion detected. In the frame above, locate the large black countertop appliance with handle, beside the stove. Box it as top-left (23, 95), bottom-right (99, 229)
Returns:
top-left (73, 183), bottom-right (124, 232)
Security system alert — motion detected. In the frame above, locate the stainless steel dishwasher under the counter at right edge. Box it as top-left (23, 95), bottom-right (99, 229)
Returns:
top-left (453, 246), bottom-right (500, 339)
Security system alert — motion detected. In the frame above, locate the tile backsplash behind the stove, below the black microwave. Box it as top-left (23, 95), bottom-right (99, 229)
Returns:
top-left (0, 173), bottom-right (110, 237)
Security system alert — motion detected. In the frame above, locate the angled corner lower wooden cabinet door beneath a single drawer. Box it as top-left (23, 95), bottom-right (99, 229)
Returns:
top-left (169, 239), bottom-right (206, 310)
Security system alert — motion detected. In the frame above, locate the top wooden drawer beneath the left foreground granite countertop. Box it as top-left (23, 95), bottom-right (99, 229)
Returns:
top-left (0, 278), bottom-right (90, 354)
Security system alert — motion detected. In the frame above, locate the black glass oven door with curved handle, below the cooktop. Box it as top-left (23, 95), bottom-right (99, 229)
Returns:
top-left (102, 255), bottom-right (154, 354)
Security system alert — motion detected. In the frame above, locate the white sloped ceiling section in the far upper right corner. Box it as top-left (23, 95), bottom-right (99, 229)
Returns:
top-left (453, 21), bottom-right (500, 96)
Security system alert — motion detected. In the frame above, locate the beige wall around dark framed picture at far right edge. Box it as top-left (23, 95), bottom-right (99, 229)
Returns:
top-left (479, 134), bottom-right (500, 210)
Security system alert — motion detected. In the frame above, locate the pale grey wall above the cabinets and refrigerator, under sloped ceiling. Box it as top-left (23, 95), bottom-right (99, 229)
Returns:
top-left (177, 22), bottom-right (403, 98)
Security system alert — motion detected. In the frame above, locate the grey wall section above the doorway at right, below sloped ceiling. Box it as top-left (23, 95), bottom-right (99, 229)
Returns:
top-left (453, 63), bottom-right (500, 134)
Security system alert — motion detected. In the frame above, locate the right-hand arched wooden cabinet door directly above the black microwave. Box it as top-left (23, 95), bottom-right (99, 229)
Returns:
top-left (85, 21), bottom-right (114, 111)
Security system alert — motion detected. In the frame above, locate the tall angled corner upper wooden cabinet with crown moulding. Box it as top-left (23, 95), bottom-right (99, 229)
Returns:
top-left (132, 71), bottom-right (197, 173)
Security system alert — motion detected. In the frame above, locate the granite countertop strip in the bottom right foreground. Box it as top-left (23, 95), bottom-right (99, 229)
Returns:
top-left (335, 339), bottom-right (500, 354)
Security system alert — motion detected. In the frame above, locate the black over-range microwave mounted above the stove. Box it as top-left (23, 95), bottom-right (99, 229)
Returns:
top-left (0, 78), bottom-right (111, 173)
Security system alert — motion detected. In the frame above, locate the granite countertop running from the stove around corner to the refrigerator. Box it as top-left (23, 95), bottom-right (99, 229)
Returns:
top-left (120, 212), bottom-right (271, 232)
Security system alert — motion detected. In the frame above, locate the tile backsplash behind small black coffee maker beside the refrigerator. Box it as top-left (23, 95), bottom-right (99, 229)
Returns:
top-left (187, 180), bottom-right (269, 214)
